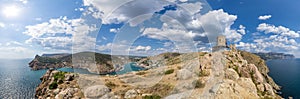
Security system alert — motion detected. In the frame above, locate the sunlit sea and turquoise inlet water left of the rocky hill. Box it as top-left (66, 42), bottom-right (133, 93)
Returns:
top-left (0, 59), bottom-right (142, 99)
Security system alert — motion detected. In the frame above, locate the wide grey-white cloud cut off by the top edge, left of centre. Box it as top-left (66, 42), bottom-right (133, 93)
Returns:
top-left (84, 0), bottom-right (168, 24)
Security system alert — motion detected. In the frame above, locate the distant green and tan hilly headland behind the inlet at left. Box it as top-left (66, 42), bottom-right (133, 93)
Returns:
top-left (29, 52), bottom-right (143, 74)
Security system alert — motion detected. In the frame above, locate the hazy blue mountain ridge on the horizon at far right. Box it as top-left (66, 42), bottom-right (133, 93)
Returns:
top-left (254, 52), bottom-right (295, 60)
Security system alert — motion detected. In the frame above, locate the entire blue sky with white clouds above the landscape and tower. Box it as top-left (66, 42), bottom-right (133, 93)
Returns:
top-left (0, 0), bottom-right (300, 59)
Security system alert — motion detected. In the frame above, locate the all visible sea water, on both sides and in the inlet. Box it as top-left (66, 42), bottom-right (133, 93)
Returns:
top-left (0, 59), bottom-right (300, 99)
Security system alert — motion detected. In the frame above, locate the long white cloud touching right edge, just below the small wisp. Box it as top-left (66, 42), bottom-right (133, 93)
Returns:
top-left (256, 23), bottom-right (300, 38)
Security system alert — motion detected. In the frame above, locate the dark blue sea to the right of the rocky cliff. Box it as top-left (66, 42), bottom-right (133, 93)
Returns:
top-left (266, 59), bottom-right (300, 99)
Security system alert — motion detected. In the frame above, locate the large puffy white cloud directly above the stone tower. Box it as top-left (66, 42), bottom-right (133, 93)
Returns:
top-left (187, 9), bottom-right (246, 43)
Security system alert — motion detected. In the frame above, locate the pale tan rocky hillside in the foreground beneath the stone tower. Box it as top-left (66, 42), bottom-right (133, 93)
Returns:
top-left (36, 51), bottom-right (281, 99)
